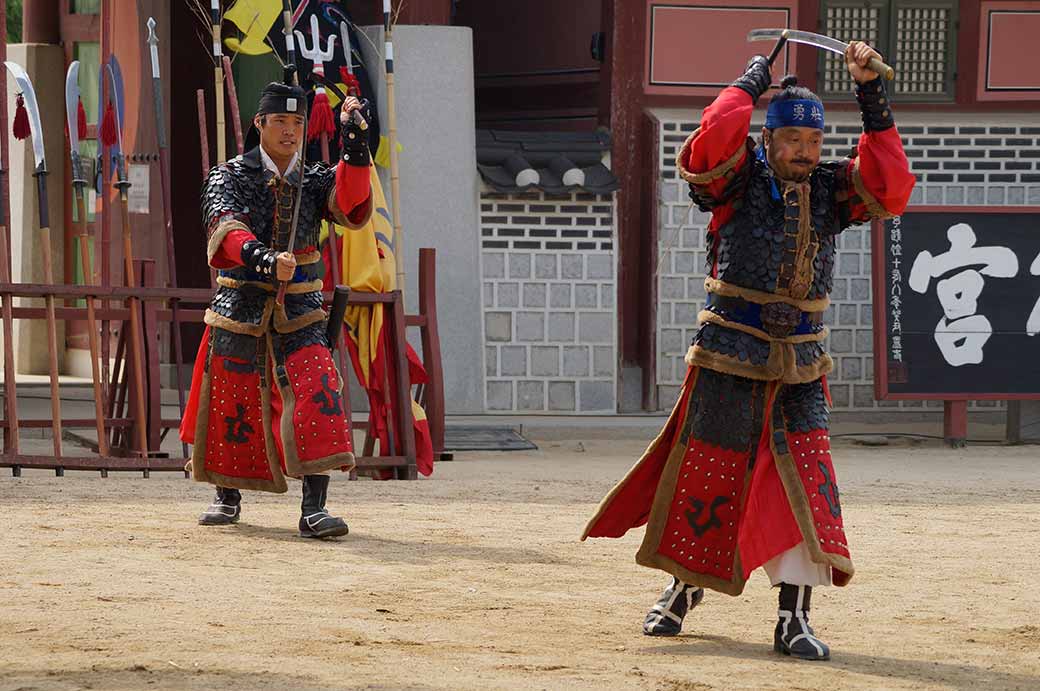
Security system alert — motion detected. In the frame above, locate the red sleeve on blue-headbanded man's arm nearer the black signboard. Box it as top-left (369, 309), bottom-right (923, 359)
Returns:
top-left (852, 127), bottom-right (916, 220)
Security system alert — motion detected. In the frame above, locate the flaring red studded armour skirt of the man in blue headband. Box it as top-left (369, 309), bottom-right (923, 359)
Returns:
top-left (581, 367), bottom-right (854, 595)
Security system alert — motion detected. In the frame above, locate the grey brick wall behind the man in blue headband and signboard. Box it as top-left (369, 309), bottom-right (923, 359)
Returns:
top-left (657, 112), bottom-right (1040, 411)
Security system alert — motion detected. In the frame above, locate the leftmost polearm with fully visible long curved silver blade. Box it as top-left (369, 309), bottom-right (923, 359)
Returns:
top-left (4, 60), bottom-right (61, 462)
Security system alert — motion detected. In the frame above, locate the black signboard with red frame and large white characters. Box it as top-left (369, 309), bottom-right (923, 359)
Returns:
top-left (874, 207), bottom-right (1040, 401)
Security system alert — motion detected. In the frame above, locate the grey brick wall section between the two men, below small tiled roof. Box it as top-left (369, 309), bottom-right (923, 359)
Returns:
top-left (480, 189), bottom-right (617, 413)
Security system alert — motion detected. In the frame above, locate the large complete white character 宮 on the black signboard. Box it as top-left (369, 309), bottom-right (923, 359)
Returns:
top-left (909, 223), bottom-right (1019, 367)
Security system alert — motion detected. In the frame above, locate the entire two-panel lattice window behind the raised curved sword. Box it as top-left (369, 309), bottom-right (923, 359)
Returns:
top-left (818, 0), bottom-right (959, 101)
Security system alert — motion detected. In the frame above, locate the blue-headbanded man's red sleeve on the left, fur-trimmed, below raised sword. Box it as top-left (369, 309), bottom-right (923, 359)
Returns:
top-left (678, 86), bottom-right (755, 199)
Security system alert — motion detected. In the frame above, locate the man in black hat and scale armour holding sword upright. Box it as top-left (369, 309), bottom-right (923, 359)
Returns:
top-left (181, 82), bottom-right (372, 538)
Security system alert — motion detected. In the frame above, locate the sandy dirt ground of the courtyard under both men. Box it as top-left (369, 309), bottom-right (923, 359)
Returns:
top-left (0, 440), bottom-right (1040, 691)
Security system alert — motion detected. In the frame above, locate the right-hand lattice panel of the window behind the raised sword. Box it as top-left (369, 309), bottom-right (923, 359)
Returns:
top-left (892, 5), bottom-right (953, 96)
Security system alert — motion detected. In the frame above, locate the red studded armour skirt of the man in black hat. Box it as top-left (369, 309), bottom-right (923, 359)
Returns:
top-left (180, 325), bottom-right (355, 492)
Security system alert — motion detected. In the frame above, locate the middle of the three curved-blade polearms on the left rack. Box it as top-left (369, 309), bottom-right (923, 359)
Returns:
top-left (66, 60), bottom-right (108, 456)
